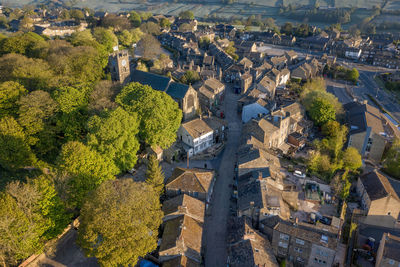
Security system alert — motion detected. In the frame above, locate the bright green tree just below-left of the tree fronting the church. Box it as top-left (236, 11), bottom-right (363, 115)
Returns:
top-left (87, 107), bottom-right (139, 172)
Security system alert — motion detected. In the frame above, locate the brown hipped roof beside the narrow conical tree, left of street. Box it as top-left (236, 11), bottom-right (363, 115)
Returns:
top-left (165, 167), bottom-right (214, 193)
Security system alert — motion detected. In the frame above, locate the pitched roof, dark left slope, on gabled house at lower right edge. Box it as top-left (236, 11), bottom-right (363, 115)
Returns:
top-left (360, 170), bottom-right (400, 201)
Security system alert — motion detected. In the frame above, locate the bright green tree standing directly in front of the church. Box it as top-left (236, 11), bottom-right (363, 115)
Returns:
top-left (116, 83), bottom-right (182, 148)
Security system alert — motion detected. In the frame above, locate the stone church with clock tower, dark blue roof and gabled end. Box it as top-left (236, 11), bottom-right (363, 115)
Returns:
top-left (109, 50), bottom-right (199, 121)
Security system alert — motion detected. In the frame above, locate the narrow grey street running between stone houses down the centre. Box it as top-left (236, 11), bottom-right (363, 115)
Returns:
top-left (204, 86), bottom-right (241, 267)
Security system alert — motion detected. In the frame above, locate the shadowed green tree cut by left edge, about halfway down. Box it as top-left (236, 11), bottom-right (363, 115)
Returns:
top-left (0, 117), bottom-right (36, 170)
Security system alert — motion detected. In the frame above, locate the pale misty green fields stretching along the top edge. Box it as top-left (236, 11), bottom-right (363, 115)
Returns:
top-left (3, 0), bottom-right (400, 28)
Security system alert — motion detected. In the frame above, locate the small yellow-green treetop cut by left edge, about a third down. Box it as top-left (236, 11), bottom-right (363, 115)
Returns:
top-left (0, 81), bottom-right (28, 117)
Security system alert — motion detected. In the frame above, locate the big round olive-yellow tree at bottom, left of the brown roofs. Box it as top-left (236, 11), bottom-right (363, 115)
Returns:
top-left (78, 179), bottom-right (163, 266)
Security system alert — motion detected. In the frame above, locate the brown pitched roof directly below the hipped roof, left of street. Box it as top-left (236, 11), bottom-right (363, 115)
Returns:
top-left (162, 194), bottom-right (205, 222)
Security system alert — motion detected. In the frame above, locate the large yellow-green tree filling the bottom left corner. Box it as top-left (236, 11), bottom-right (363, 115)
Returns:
top-left (0, 176), bottom-right (69, 265)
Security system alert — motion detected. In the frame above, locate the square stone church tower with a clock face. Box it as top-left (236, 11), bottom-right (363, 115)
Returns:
top-left (108, 50), bottom-right (131, 84)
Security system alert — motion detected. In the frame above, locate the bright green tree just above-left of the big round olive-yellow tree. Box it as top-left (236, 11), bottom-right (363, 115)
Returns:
top-left (57, 141), bottom-right (118, 209)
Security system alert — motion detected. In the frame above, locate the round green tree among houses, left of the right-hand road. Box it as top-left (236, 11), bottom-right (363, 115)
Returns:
top-left (308, 97), bottom-right (336, 126)
